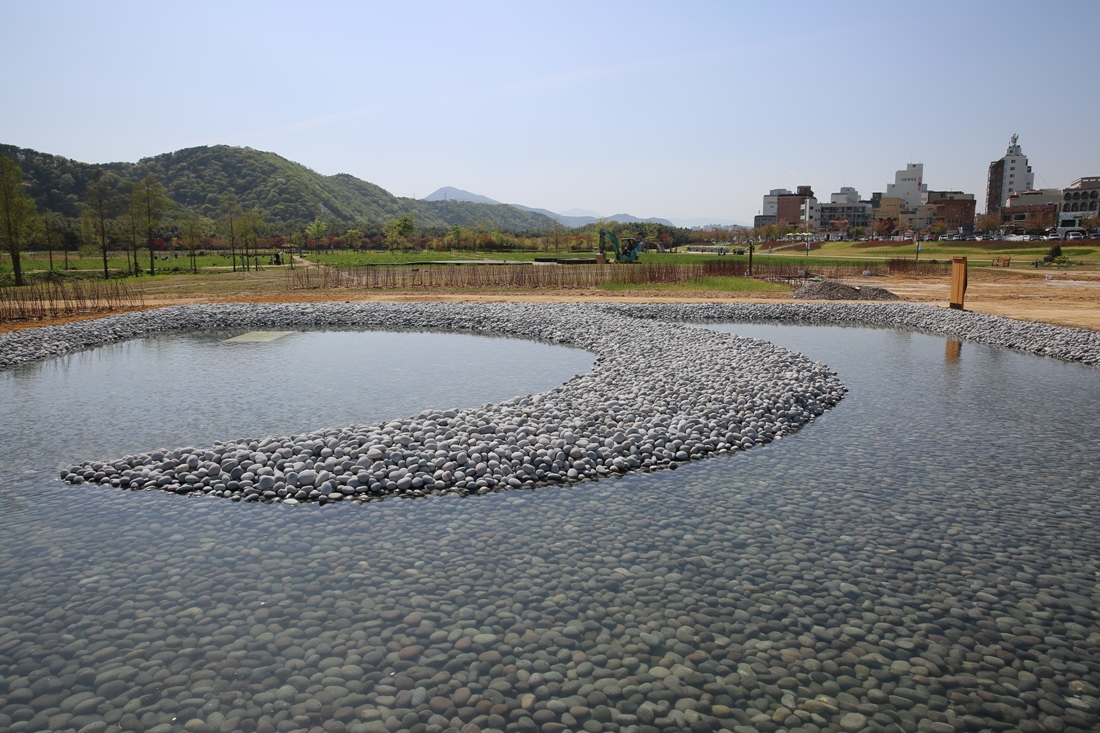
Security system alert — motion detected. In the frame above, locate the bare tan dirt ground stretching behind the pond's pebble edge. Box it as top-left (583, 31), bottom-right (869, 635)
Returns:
top-left (0, 269), bottom-right (1100, 333)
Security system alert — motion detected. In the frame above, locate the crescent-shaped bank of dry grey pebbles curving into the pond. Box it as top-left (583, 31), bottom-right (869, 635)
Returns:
top-left (2, 304), bottom-right (845, 504)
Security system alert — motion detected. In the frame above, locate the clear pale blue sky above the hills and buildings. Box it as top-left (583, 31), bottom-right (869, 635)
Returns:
top-left (0, 0), bottom-right (1100, 222)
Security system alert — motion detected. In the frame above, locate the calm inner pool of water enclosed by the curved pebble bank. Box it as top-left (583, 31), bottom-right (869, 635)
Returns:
top-left (0, 330), bottom-right (592, 488)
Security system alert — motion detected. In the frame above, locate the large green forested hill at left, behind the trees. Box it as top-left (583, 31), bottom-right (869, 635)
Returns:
top-left (0, 145), bottom-right (554, 230)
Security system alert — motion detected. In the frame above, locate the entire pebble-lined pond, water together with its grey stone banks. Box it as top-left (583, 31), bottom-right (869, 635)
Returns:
top-left (0, 303), bottom-right (1100, 733)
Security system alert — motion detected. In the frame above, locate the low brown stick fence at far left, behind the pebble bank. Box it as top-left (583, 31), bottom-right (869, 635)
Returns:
top-left (0, 281), bottom-right (145, 324)
